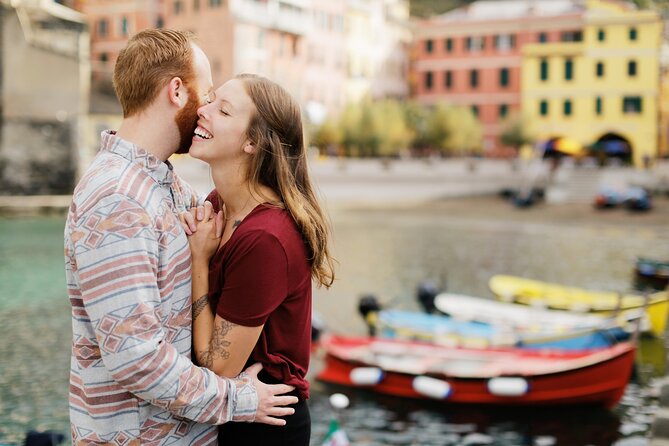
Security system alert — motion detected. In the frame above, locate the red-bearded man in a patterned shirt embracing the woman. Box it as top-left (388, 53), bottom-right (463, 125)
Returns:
top-left (65, 30), bottom-right (297, 445)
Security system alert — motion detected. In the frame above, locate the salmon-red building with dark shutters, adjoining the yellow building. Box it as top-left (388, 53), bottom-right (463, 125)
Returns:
top-left (411, 0), bottom-right (583, 156)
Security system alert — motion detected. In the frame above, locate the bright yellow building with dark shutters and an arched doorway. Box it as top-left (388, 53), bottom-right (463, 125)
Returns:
top-left (521, 0), bottom-right (662, 166)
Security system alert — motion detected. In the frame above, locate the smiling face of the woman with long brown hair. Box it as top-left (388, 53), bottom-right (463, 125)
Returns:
top-left (190, 79), bottom-right (255, 164)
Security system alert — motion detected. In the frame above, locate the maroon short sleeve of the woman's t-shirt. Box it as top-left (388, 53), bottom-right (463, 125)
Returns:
top-left (216, 230), bottom-right (288, 327)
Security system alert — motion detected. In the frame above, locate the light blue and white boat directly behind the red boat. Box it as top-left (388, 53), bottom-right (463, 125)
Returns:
top-left (374, 308), bottom-right (630, 349)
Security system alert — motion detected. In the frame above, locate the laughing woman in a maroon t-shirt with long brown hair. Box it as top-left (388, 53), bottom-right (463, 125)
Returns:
top-left (187, 75), bottom-right (334, 445)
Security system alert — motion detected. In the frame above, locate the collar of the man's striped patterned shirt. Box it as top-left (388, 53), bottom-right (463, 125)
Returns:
top-left (101, 130), bottom-right (174, 186)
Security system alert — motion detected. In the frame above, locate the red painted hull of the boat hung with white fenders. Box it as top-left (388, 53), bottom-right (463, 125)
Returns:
top-left (317, 338), bottom-right (635, 408)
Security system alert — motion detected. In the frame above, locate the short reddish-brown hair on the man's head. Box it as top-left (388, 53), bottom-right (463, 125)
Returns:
top-left (113, 29), bottom-right (195, 118)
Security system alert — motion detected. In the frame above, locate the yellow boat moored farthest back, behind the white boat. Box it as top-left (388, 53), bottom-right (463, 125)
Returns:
top-left (488, 274), bottom-right (669, 336)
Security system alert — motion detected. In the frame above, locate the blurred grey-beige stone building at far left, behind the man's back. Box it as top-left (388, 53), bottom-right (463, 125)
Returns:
top-left (0, 0), bottom-right (90, 195)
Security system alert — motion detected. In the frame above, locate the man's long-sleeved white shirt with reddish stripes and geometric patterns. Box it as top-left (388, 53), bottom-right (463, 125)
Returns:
top-left (65, 131), bottom-right (257, 445)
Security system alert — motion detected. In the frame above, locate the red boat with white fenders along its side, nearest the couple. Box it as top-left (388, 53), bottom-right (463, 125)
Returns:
top-left (317, 336), bottom-right (636, 407)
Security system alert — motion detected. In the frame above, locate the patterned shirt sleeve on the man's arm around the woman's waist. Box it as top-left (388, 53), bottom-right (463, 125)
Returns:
top-left (73, 195), bottom-right (257, 424)
